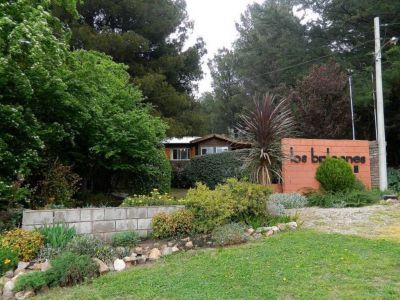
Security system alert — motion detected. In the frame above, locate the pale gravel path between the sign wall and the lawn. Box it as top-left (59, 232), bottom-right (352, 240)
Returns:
top-left (289, 203), bottom-right (400, 241)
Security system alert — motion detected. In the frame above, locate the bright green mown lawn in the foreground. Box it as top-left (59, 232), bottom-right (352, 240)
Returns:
top-left (37, 230), bottom-right (400, 299)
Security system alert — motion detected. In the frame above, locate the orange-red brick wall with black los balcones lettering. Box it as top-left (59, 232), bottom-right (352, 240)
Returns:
top-left (282, 139), bottom-right (371, 193)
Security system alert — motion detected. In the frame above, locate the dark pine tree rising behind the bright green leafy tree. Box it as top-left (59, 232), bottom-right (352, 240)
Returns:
top-left (55, 0), bottom-right (205, 135)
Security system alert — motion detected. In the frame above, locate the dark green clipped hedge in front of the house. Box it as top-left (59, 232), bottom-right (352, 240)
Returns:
top-left (184, 150), bottom-right (245, 188)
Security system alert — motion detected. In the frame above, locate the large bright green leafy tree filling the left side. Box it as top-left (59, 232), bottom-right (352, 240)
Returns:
top-left (0, 0), bottom-right (170, 202)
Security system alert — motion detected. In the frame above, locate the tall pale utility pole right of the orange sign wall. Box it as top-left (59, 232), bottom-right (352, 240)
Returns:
top-left (374, 17), bottom-right (387, 191)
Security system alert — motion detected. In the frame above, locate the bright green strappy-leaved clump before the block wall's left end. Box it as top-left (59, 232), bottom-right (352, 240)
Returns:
top-left (37, 224), bottom-right (76, 249)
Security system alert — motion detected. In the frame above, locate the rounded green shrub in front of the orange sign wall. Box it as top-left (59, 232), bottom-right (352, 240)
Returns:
top-left (316, 157), bottom-right (356, 193)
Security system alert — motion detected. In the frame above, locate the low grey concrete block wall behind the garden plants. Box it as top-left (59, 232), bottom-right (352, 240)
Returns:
top-left (22, 205), bottom-right (184, 239)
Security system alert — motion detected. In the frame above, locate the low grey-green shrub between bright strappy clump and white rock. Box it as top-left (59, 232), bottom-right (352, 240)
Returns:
top-left (66, 235), bottom-right (115, 262)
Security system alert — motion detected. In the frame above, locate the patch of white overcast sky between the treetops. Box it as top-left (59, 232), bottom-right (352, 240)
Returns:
top-left (186, 0), bottom-right (263, 94)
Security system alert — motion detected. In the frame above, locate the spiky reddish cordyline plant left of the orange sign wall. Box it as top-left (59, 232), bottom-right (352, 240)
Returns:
top-left (237, 94), bottom-right (295, 185)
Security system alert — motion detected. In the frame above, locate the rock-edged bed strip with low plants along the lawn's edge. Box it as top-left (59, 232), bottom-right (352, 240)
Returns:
top-left (0, 222), bottom-right (297, 299)
